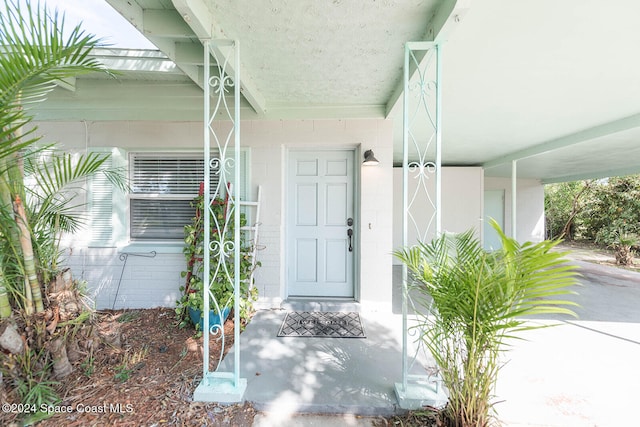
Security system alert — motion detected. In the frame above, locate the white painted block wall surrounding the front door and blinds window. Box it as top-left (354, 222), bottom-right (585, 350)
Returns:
top-left (38, 119), bottom-right (393, 308)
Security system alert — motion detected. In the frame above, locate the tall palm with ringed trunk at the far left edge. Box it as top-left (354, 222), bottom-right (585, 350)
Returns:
top-left (0, 0), bottom-right (105, 318)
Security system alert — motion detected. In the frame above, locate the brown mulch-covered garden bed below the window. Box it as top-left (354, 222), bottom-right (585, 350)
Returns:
top-left (0, 308), bottom-right (255, 427)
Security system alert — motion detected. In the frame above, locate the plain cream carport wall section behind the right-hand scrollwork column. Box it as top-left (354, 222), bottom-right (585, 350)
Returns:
top-left (393, 167), bottom-right (483, 264)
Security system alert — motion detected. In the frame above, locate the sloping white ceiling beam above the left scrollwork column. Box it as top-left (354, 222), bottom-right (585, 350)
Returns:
top-left (172, 0), bottom-right (266, 116)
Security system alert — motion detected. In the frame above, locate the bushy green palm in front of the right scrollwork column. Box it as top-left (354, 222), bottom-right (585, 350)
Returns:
top-left (394, 222), bottom-right (576, 427)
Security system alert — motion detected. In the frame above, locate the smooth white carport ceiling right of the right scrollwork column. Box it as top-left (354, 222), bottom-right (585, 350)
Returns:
top-left (443, 0), bottom-right (640, 180)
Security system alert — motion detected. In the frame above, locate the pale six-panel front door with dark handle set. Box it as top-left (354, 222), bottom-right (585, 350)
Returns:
top-left (286, 150), bottom-right (355, 298)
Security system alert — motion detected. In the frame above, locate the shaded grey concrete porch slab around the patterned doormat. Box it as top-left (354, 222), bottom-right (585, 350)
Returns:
top-left (222, 304), bottom-right (430, 426)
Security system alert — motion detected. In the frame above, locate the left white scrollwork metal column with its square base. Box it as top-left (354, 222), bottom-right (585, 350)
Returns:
top-left (193, 40), bottom-right (247, 403)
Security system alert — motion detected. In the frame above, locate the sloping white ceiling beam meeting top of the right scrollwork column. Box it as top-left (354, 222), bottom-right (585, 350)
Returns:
top-left (386, 0), bottom-right (471, 117)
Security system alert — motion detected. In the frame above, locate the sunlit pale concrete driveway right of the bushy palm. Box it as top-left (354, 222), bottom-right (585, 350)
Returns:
top-left (497, 256), bottom-right (640, 427)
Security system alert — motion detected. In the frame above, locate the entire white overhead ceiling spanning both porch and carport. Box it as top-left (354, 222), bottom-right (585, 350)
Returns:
top-left (37, 0), bottom-right (640, 181)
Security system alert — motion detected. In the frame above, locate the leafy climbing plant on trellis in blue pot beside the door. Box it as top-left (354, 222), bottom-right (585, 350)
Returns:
top-left (176, 184), bottom-right (260, 331)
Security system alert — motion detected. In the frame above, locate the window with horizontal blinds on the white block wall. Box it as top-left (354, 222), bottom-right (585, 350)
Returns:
top-left (129, 153), bottom-right (218, 240)
